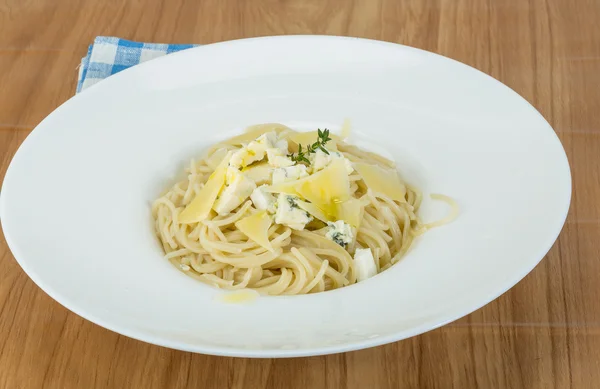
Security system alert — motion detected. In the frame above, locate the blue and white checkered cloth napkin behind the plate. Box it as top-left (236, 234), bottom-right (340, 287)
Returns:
top-left (77, 36), bottom-right (197, 93)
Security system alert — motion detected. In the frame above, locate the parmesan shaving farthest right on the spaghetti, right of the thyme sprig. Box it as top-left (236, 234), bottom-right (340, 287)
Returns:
top-left (354, 163), bottom-right (406, 202)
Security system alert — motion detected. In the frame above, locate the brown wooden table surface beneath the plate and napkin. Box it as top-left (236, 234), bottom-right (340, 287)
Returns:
top-left (0, 0), bottom-right (600, 389)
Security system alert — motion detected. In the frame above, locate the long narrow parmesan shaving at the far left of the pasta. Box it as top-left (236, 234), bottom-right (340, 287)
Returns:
top-left (179, 153), bottom-right (231, 224)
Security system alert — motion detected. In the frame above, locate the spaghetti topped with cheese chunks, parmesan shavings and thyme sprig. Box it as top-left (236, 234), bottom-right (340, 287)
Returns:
top-left (152, 124), bottom-right (457, 295)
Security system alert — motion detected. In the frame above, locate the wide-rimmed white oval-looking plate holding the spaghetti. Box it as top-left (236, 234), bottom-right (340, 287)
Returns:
top-left (0, 36), bottom-right (571, 357)
